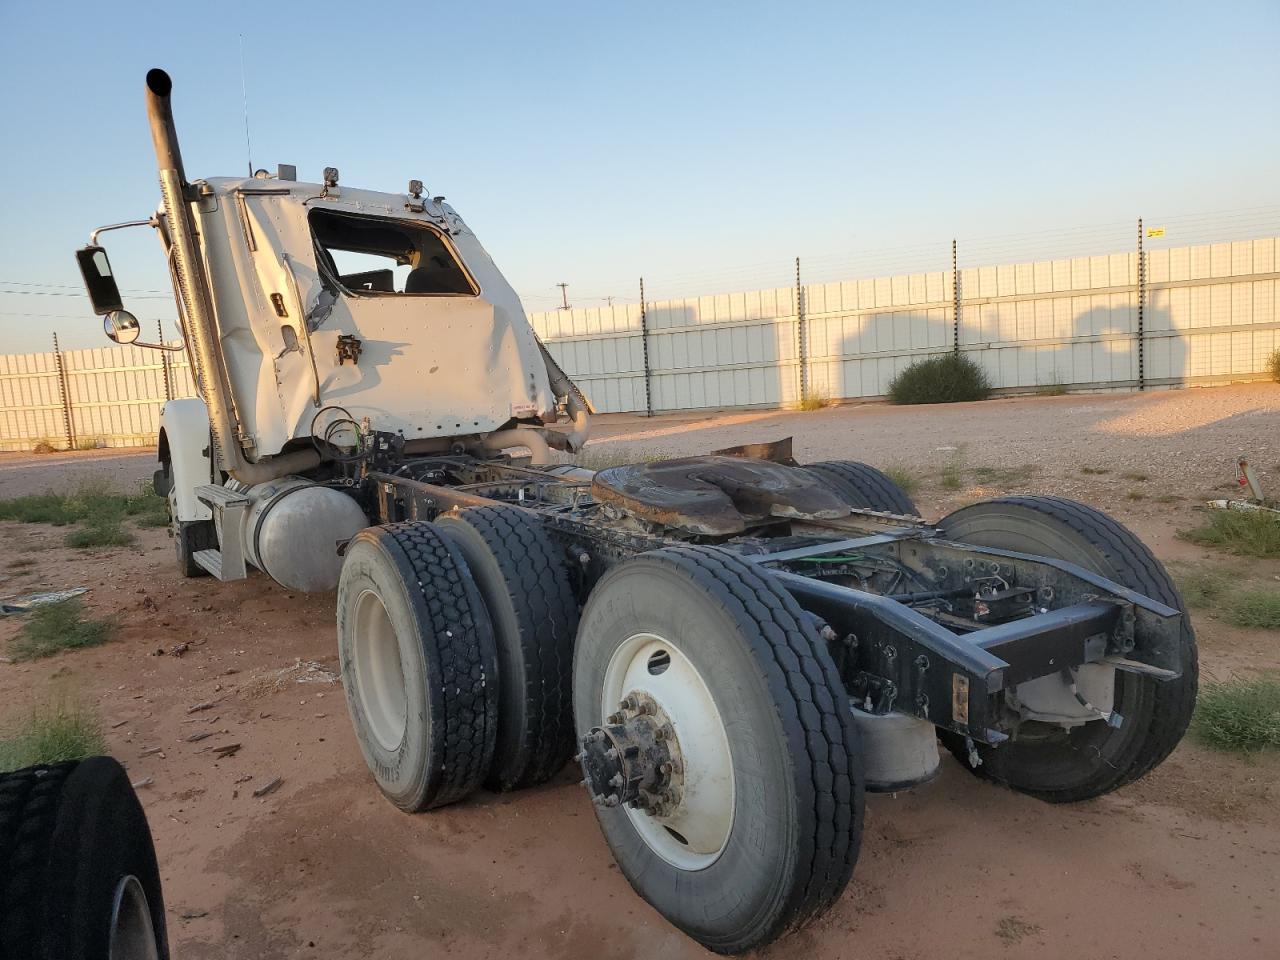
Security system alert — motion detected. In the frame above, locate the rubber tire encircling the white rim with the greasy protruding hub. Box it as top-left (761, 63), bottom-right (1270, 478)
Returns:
top-left (573, 547), bottom-right (863, 954)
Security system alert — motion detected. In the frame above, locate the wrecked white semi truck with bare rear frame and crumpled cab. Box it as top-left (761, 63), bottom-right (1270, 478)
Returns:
top-left (78, 69), bottom-right (1197, 954)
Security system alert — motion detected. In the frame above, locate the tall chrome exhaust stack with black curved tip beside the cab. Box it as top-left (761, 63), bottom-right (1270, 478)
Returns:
top-left (146, 68), bottom-right (320, 485)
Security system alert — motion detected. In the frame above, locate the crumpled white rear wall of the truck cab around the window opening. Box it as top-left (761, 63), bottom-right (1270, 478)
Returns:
top-left (190, 179), bottom-right (556, 457)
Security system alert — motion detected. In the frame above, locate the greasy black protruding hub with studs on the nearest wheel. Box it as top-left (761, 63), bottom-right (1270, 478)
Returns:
top-left (576, 692), bottom-right (684, 817)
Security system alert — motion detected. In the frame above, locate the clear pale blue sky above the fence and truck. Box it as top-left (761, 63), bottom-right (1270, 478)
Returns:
top-left (0, 0), bottom-right (1280, 352)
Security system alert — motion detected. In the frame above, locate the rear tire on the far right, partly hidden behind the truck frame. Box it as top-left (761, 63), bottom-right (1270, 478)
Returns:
top-left (938, 497), bottom-right (1199, 803)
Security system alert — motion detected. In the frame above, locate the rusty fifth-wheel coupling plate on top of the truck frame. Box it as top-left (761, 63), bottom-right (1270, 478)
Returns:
top-left (591, 456), bottom-right (849, 536)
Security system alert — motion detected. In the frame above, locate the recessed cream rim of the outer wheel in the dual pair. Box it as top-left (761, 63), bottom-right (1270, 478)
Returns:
top-left (352, 590), bottom-right (408, 753)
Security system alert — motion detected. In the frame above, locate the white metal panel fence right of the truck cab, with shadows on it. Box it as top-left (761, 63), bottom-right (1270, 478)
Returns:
top-left (531, 238), bottom-right (1280, 412)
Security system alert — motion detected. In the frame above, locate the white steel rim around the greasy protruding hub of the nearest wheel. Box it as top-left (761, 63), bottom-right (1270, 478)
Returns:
top-left (600, 634), bottom-right (735, 870)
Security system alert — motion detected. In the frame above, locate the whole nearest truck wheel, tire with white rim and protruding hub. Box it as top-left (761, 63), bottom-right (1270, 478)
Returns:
top-left (573, 547), bottom-right (863, 954)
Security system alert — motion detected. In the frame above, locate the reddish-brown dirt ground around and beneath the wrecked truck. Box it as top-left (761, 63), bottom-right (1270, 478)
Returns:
top-left (0, 385), bottom-right (1280, 960)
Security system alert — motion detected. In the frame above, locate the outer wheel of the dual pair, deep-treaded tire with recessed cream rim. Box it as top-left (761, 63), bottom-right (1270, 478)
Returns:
top-left (338, 522), bottom-right (498, 812)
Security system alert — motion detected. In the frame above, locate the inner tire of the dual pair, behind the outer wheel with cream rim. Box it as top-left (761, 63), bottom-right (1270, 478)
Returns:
top-left (436, 506), bottom-right (577, 790)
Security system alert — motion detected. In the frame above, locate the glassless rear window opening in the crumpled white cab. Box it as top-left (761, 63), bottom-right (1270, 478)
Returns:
top-left (308, 210), bottom-right (480, 297)
